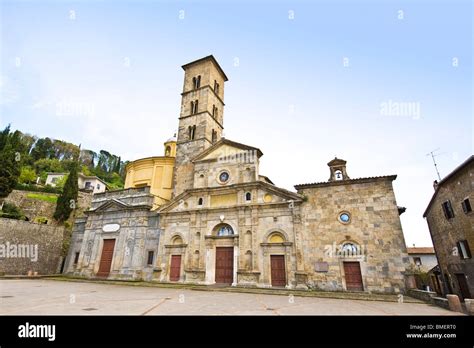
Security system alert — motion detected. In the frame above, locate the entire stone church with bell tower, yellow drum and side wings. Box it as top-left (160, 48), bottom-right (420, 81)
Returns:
top-left (65, 55), bottom-right (409, 293)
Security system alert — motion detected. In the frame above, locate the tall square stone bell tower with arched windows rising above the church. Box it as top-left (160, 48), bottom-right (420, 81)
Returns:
top-left (173, 55), bottom-right (228, 197)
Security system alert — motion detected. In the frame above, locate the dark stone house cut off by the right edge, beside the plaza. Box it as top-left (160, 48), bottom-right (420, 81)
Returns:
top-left (423, 156), bottom-right (474, 299)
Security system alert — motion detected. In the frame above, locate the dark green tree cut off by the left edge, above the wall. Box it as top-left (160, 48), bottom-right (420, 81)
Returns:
top-left (0, 126), bottom-right (21, 207)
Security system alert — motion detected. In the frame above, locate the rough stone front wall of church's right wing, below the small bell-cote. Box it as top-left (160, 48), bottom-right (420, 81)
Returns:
top-left (298, 177), bottom-right (409, 293)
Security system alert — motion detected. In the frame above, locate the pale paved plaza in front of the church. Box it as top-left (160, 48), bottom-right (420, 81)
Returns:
top-left (0, 279), bottom-right (459, 315)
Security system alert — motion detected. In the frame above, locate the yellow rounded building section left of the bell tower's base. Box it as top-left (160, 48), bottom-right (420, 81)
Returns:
top-left (125, 137), bottom-right (176, 210)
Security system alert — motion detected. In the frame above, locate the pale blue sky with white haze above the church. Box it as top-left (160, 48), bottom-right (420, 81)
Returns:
top-left (0, 0), bottom-right (474, 246)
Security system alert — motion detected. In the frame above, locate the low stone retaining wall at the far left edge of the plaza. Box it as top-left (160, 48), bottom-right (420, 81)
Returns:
top-left (0, 218), bottom-right (65, 275)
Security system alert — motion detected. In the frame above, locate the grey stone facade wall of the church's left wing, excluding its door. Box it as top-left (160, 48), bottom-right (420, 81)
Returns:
top-left (64, 187), bottom-right (160, 280)
